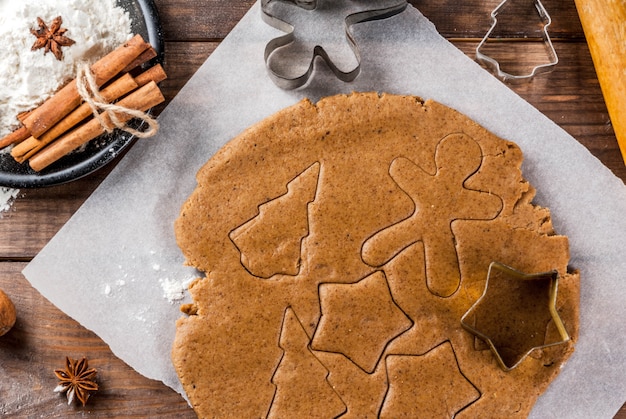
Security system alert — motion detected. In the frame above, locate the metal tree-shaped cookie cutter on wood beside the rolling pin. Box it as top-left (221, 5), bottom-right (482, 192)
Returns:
top-left (476, 0), bottom-right (559, 83)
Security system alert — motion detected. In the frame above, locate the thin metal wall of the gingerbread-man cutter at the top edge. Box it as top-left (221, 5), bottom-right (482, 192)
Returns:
top-left (261, 0), bottom-right (407, 90)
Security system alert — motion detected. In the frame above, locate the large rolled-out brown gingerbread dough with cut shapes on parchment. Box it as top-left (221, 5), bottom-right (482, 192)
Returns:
top-left (172, 93), bottom-right (579, 418)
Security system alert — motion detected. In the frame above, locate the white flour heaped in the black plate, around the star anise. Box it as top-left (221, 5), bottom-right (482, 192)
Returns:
top-left (0, 0), bottom-right (132, 138)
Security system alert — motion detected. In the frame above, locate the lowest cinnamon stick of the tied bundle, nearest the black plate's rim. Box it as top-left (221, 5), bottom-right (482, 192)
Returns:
top-left (29, 82), bottom-right (165, 172)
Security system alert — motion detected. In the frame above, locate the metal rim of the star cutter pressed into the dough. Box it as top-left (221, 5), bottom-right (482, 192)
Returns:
top-left (461, 262), bottom-right (570, 371)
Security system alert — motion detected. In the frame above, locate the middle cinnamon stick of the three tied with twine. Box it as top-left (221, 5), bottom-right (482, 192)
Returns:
top-left (11, 73), bottom-right (139, 163)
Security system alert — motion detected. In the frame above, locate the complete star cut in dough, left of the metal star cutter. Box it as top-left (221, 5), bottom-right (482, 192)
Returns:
top-left (311, 271), bottom-right (413, 373)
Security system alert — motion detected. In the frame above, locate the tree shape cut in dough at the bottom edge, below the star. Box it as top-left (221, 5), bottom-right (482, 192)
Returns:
top-left (268, 308), bottom-right (347, 419)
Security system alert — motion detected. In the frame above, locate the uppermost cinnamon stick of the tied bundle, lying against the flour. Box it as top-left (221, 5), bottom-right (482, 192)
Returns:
top-left (23, 35), bottom-right (150, 138)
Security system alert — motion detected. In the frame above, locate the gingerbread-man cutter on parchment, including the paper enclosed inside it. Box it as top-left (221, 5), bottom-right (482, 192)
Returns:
top-left (261, 0), bottom-right (407, 90)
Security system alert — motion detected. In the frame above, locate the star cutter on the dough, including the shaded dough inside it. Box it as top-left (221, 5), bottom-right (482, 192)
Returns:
top-left (461, 262), bottom-right (570, 371)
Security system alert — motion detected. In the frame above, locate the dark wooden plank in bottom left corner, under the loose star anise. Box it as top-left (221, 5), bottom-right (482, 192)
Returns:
top-left (0, 262), bottom-right (195, 418)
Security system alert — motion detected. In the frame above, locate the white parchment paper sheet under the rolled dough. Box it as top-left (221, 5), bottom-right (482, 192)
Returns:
top-left (24, 4), bottom-right (626, 418)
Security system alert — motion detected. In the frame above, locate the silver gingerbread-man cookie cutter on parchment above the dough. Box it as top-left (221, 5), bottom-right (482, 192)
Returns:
top-left (261, 0), bottom-right (407, 90)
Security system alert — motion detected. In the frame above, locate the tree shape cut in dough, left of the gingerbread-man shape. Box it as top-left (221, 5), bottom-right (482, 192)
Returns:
top-left (230, 163), bottom-right (320, 279)
